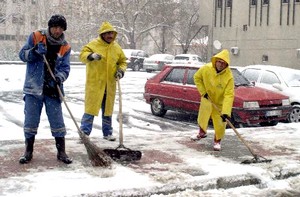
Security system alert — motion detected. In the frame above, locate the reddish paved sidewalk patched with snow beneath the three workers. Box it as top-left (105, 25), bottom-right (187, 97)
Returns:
top-left (0, 130), bottom-right (300, 196)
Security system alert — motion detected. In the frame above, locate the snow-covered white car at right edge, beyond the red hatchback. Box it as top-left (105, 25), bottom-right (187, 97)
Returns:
top-left (242, 65), bottom-right (300, 122)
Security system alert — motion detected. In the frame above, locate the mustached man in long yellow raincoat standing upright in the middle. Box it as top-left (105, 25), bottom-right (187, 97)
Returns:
top-left (79, 22), bottom-right (127, 141)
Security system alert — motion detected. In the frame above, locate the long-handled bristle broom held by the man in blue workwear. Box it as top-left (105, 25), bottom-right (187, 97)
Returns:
top-left (43, 55), bottom-right (112, 167)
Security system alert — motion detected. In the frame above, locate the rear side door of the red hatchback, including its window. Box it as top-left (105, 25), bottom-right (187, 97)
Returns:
top-left (159, 67), bottom-right (185, 109)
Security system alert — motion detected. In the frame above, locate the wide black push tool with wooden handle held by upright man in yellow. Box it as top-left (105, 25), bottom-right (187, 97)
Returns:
top-left (103, 78), bottom-right (142, 162)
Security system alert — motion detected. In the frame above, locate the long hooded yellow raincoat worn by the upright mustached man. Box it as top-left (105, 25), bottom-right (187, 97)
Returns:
top-left (79, 22), bottom-right (127, 116)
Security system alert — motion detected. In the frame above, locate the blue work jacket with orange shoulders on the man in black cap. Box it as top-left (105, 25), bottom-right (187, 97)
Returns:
top-left (19, 30), bottom-right (71, 95)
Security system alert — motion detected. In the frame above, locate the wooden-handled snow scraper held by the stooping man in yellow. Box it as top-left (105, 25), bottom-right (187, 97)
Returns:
top-left (208, 98), bottom-right (272, 164)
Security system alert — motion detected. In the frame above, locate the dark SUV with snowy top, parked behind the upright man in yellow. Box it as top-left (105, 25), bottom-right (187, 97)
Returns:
top-left (123, 49), bottom-right (148, 71)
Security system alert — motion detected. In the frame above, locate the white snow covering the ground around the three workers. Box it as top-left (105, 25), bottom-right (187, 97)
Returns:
top-left (0, 64), bottom-right (300, 197)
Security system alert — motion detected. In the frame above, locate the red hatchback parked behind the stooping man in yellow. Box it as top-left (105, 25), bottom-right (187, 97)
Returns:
top-left (144, 64), bottom-right (292, 126)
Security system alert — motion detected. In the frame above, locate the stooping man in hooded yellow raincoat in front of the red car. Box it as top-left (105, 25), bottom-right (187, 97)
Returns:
top-left (193, 50), bottom-right (234, 151)
